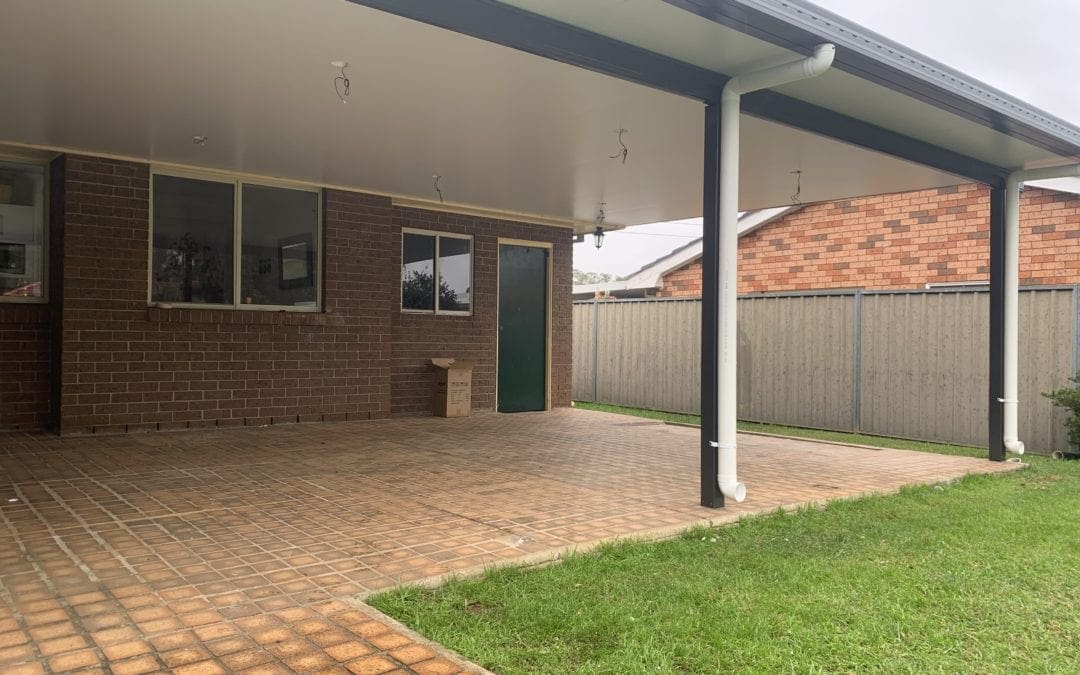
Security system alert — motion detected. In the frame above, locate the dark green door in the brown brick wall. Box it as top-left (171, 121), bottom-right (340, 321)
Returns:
top-left (499, 244), bottom-right (548, 413)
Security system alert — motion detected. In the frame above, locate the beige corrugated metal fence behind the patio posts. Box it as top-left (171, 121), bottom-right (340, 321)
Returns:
top-left (573, 287), bottom-right (1080, 453)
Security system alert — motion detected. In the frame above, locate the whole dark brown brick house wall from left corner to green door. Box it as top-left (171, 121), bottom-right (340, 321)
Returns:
top-left (46, 156), bottom-right (571, 433)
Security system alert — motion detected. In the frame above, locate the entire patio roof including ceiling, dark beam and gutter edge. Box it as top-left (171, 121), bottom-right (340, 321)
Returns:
top-left (0, 0), bottom-right (1080, 230)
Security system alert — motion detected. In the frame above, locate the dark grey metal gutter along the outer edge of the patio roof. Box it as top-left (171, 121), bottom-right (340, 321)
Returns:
top-left (664, 0), bottom-right (1080, 159)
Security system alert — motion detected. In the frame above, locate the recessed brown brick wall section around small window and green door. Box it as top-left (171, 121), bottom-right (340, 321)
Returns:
top-left (391, 207), bottom-right (573, 414)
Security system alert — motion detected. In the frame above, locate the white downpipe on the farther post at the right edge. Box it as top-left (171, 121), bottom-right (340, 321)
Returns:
top-left (999, 164), bottom-right (1080, 455)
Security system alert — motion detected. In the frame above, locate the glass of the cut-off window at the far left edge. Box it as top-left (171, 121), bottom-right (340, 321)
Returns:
top-left (0, 163), bottom-right (45, 298)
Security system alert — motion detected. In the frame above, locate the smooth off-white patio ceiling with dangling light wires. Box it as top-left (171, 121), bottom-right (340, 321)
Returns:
top-left (0, 0), bottom-right (960, 225)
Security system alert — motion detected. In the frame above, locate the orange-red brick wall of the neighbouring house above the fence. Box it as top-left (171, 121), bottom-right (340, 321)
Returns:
top-left (658, 185), bottom-right (1080, 297)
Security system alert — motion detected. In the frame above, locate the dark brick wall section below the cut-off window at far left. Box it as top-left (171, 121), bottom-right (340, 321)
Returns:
top-left (0, 303), bottom-right (52, 431)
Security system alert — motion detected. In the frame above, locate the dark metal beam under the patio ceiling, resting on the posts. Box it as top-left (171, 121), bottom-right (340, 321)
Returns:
top-left (349, 0), bottom-right (1009, 187)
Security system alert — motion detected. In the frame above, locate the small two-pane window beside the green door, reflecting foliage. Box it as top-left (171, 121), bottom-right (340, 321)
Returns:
top-left (402, 232), bottom-right (472, 313)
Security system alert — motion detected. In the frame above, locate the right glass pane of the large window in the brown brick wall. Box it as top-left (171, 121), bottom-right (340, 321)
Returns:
top-left (240, 185), bottom-right (319, 307)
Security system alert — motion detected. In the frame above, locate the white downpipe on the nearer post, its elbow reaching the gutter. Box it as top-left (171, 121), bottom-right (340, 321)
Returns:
top-left (715, 44), bottom-right (836, 502)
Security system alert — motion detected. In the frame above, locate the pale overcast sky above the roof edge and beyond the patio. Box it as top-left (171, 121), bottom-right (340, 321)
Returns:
top-left (573, 0), bottom-right (1080, 276)
